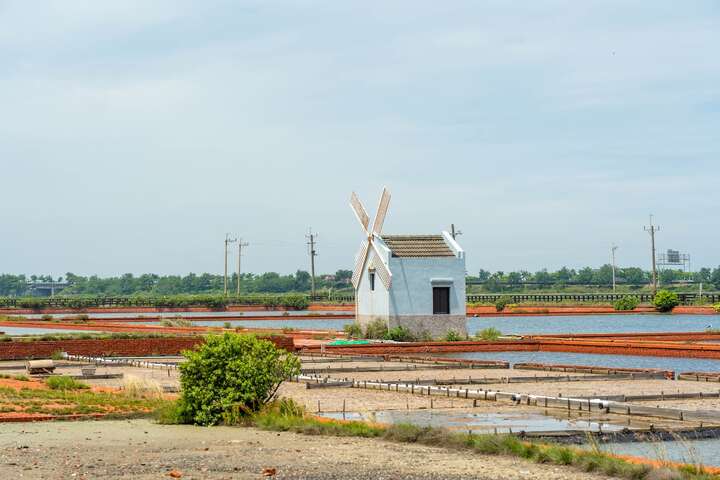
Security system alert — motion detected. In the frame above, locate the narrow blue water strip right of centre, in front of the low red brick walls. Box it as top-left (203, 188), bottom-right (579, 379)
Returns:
top-left (433, 352), bottom-right (720, 373)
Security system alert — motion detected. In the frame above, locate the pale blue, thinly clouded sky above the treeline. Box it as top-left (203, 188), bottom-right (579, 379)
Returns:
top-left (0, 0), bottom-right (720, 276)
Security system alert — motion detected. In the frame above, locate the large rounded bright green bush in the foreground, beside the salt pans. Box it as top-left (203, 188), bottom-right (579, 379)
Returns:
top-left (178, 333), bottom-right (300, 425)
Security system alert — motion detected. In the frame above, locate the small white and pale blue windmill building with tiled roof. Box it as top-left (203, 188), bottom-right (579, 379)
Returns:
top-left (350, 188), bottom-right (467, 338)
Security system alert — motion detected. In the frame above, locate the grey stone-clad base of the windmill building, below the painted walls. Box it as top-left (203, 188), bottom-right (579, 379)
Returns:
top-left (357, 315), bottom-right (467, 339)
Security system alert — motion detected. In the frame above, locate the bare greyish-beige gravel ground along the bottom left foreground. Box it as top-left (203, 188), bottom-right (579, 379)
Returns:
top-left (0, 420), bottom-right (607, 480)
